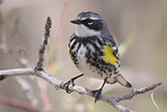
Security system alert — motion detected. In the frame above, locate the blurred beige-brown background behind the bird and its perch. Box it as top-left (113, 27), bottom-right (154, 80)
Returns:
top-left (0, 0), bottom-right (167, 112)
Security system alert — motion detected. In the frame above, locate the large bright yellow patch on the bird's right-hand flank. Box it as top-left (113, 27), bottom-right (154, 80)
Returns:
top-left (102, 45), bottom-right (117, 64)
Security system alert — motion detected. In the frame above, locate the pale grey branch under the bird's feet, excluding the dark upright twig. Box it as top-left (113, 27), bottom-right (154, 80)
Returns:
top-left (0, 68), bottom-right (162, 112)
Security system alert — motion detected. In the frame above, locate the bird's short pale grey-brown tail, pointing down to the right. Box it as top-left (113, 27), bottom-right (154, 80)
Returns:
top-left (114, 74), bottom-right (132, 88)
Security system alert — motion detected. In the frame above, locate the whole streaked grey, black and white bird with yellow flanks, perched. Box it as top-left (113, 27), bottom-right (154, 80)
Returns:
top-left (66, 11), bottom-right (132, 102)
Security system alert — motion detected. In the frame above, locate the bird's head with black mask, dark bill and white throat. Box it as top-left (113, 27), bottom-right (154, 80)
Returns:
top-left (71, 11), bottom-right (108, 37)
